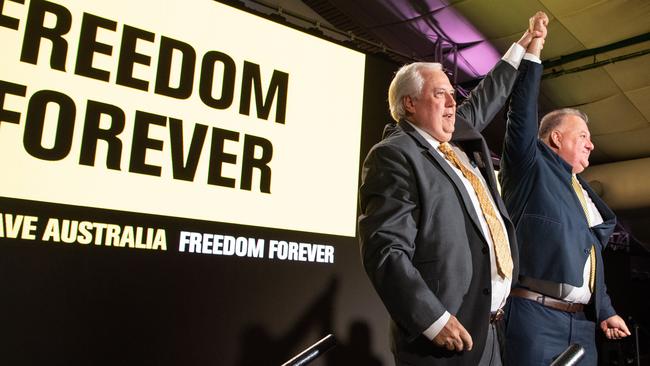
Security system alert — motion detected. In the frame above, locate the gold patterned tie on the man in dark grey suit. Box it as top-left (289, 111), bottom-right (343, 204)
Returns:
top-left (439, 142), bottom-right (512, 278)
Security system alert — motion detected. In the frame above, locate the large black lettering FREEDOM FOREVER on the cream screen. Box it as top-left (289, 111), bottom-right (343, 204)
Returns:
top-left (0, 0), bottom-right (289, 193)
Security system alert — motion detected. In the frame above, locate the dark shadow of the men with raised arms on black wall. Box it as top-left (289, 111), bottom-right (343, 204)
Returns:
top-left (237, 278), bottom-right (382, 366)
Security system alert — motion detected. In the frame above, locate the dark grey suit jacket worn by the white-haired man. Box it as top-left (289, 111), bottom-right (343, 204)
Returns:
top-left (359, 61), bottom-right (517, 365)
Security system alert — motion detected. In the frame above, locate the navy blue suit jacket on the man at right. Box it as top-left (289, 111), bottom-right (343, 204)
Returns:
top-left (499, 60), bottom-right (616, 320)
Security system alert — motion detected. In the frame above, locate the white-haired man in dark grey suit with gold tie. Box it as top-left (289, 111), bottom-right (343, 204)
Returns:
top-left (359, 14), bottom-right (541, 366)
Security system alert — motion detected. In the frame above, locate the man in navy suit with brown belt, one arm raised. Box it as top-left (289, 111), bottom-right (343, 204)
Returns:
top-left (499, 12), bottom-right (630, 366)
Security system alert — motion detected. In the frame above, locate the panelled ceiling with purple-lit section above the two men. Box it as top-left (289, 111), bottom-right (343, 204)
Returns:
top-left (233, 0), bottom-right (650, 250)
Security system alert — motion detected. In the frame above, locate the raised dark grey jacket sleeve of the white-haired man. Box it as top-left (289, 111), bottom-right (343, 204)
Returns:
top-left (456, 60), bottom-right (517, 132)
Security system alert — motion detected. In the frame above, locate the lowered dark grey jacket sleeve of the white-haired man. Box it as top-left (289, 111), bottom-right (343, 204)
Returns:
top-left (359, 145), bottom-right (446, 340)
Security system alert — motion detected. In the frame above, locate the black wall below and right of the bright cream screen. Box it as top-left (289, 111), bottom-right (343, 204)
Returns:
top-left (0, 51), bottom-right (396, 365)
